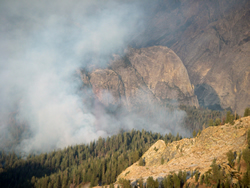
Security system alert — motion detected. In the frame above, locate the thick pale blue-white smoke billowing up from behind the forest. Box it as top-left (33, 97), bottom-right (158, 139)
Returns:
top-left (0, 0), bottom-right (188, 153)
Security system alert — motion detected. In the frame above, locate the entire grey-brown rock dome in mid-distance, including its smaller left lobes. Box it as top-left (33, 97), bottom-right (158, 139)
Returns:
top-left (81, 46), bottom-right (198, 109)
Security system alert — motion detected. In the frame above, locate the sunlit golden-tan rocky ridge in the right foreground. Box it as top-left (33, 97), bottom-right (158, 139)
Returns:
top-left (117, 116), bottom-right (250, 182)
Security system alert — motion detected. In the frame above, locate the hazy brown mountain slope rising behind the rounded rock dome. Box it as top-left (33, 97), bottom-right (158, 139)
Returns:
top-left (134, 0), bottom-right (250, 114)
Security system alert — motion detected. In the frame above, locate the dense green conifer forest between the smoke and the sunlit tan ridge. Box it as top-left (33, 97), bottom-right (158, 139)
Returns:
top-left (0, 130), bottom-right (182, 188)
